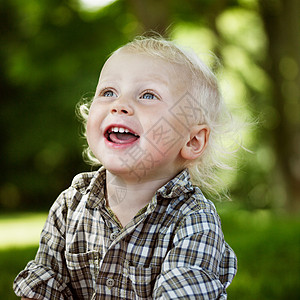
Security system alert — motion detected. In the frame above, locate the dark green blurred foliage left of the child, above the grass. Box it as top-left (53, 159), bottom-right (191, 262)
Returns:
top-left (0, 0), bottom-right (134, 209)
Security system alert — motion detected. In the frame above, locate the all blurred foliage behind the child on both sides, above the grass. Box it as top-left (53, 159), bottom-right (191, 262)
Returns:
top-left (0, 0), bottom-right (300, 210)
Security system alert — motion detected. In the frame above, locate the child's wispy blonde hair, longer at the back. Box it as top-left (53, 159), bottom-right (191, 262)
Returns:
top-left (78, 37), bottom-right (238, 197)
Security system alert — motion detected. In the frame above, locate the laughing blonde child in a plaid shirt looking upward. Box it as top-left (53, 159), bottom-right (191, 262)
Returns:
top-left (14, 38), bottom-right (236, 299)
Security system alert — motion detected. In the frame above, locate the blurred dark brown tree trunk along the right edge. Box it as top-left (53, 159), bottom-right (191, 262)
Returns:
top-left (260, 0), bottom-right (300, 211)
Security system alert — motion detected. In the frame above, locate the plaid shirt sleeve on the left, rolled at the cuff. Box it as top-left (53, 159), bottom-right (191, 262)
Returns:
top-left (13, 193), bottom-right (73, 300)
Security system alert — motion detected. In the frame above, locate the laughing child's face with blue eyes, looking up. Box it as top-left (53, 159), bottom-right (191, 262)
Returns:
top-left (87, 49), bottom-right (195, 181)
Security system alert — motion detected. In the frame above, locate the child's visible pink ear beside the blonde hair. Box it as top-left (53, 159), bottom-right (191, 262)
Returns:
top-left (180, 125), bottom-right (210, 160)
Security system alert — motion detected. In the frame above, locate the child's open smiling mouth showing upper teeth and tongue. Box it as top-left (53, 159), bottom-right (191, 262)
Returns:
top-left (104, 126), bottom-right (140, 144)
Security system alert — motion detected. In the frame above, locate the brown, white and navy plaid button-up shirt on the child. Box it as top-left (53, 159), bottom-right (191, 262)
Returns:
top-left (14, 168), bottom-right (237, 299)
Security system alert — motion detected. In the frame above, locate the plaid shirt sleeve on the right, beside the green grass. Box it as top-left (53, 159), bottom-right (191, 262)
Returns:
top-left (153, 213), bottom-right (236, 300)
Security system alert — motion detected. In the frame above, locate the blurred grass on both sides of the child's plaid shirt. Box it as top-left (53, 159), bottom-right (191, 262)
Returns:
top-left (0, 204), bottom-right (300, 300)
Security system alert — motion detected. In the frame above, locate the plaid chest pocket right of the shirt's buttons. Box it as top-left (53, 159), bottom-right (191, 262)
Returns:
top-left (128, 266), bottom-right (160, 299)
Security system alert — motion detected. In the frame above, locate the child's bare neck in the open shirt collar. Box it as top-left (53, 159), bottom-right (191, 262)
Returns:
top-left (106, 170), bottom-right (171, 226)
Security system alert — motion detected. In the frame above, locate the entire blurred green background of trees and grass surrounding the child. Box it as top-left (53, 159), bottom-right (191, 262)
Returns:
top-left (0, 0), bottom-right (300, 299)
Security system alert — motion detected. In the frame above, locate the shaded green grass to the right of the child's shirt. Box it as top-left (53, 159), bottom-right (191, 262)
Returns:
top-left (220, 206), bottom-right (300, 300)
